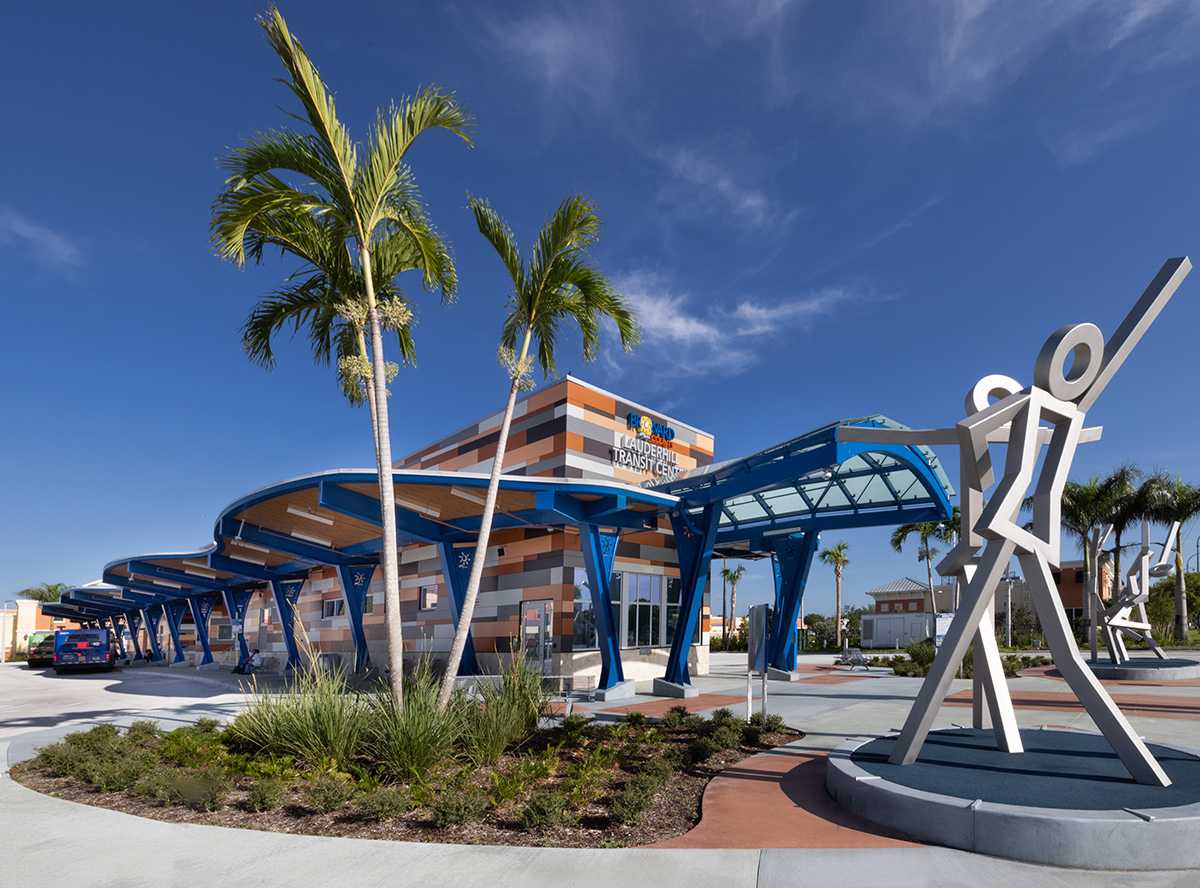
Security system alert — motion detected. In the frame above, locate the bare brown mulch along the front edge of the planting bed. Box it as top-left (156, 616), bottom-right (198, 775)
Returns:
top-left (10, 728), bottom-right (804, 848)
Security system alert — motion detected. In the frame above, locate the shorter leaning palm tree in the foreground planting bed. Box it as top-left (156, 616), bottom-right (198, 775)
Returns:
top-left (438, 194), bottom-right (640, 709)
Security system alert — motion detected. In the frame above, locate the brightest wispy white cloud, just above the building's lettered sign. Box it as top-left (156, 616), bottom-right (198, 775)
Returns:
top-left (606, 271), bottom-right (878, 378)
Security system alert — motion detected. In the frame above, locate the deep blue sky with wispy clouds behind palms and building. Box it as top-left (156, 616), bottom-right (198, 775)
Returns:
top-left (0, 0), bottom-right (1200, 612)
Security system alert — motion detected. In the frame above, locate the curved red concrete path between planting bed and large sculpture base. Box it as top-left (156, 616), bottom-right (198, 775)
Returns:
top-left (646, 750), bottom-right (923, 848)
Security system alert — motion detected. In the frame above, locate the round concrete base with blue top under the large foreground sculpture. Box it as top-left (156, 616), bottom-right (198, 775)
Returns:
top-left (826, 728), bottom-right (1200, 870)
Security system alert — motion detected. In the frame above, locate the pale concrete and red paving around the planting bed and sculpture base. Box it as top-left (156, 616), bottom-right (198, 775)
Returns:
top-left (0, 654), bottom-right (1200, 888)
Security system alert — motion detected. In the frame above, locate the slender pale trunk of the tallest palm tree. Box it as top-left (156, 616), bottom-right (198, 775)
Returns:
top-left (362, 244), bottom-right (404, 709)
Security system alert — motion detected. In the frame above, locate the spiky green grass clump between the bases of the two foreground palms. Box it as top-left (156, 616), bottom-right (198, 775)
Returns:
top-left (368, 661), bottom-right (464, 781)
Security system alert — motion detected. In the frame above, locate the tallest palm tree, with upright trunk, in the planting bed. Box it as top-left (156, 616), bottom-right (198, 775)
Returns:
top-left (212, 7), bottom-right (470, 707)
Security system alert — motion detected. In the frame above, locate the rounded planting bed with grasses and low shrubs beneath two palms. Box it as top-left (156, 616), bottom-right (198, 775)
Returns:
top-left (11, 668), bottom-right (803, 847)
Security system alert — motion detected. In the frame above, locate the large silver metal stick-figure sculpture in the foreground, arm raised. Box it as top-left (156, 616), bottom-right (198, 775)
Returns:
top-left (844, 258), bottom-right (1192, 786)
